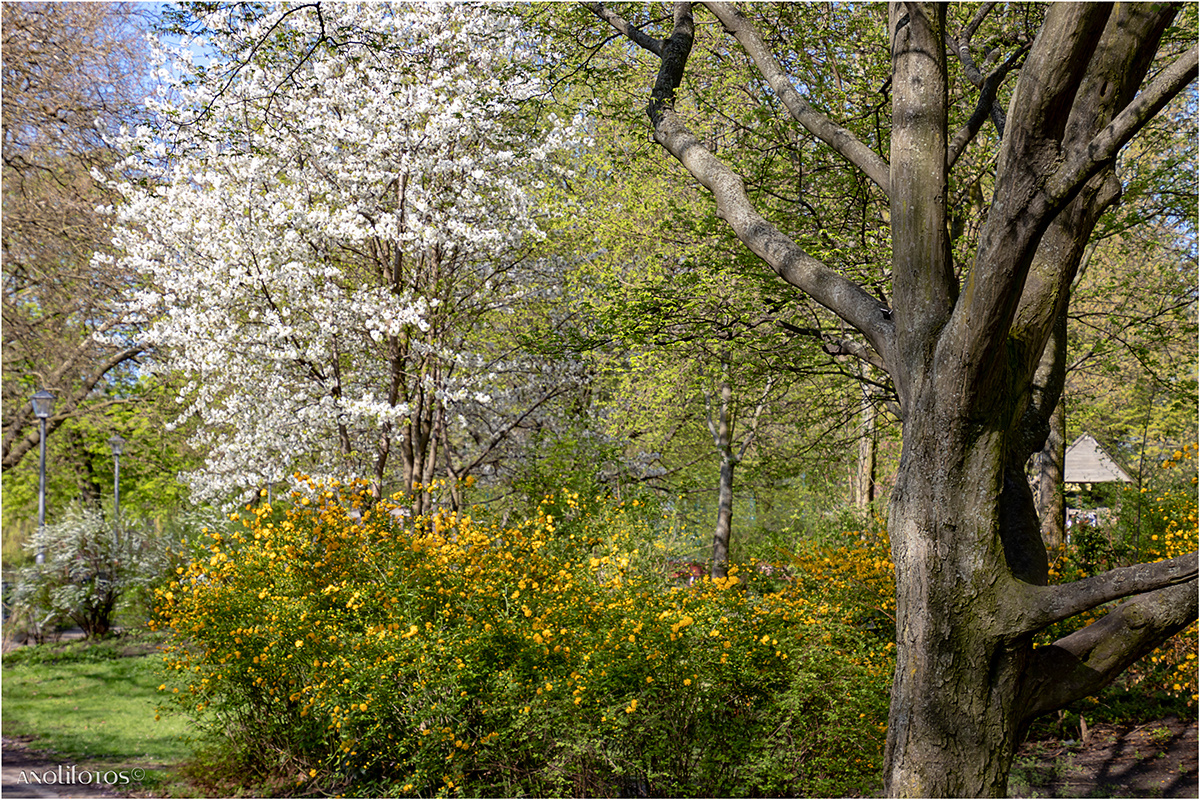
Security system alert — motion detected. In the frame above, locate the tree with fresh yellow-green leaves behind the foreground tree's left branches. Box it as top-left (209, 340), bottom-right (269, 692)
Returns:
top-left (542, 8), bottom-right (887, 572)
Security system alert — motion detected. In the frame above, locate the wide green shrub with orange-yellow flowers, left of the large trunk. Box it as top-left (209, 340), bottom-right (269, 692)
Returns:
top-left (158, 485), bottom-right (892, 796)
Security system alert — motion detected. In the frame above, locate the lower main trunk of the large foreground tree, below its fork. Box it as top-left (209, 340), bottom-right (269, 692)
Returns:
top-left (884, 416), bottom-right (1045, 798)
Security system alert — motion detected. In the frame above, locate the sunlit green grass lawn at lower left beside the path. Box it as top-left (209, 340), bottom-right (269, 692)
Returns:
top-left (2, 637), bottom-right (192, 793)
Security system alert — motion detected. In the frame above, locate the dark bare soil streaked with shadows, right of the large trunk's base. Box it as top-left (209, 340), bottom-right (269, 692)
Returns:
top-left (1008, 717), bottom-right (1200, 798)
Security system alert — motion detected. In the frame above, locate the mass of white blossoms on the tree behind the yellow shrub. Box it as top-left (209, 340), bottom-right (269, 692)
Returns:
top-left (105, 4), bottom-right (575, 499)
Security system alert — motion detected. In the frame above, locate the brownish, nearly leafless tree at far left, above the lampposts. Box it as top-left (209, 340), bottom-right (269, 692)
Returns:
top-left (0, 2), bottom-right (149, 473)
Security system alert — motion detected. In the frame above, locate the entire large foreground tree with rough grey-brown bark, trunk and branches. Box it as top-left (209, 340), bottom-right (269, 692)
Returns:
top-left (586, 2), bottom-right (1198, 796)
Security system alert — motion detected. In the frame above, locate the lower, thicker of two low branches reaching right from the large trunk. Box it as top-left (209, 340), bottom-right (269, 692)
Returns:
top-left (1019, 575), bottom-right (1198, 724)
